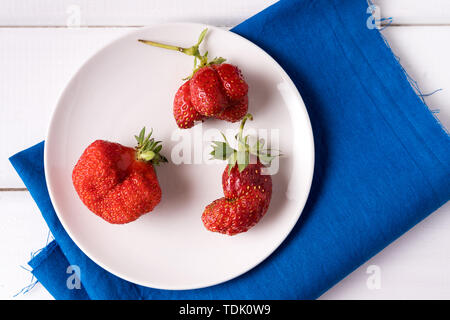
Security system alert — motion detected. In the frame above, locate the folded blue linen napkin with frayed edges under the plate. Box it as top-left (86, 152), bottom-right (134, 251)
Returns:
top-left (11, 0), bottom-right (450, 299)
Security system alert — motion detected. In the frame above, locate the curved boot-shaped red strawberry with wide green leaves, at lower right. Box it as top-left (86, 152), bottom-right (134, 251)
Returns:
top-left (202, 114), bottom-right (280, 235)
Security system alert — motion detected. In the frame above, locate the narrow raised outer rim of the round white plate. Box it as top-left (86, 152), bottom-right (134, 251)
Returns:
top-left (44, 22), bottom-right (315, 291)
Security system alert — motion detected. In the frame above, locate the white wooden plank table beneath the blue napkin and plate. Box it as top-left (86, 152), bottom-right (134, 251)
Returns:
top-left (0, 0), bottom-right (450, 299)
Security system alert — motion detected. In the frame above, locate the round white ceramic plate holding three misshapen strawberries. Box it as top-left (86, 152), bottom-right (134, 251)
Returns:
top-left (45, 24), bottom-right (314, 289)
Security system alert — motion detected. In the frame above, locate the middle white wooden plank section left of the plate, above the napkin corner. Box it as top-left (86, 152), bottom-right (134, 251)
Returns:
top-left (0, 28), bottom-right (131, 188)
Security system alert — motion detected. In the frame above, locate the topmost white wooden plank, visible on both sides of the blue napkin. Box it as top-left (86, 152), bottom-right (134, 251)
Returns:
top-left (0, 0), bottom-right (450, 26)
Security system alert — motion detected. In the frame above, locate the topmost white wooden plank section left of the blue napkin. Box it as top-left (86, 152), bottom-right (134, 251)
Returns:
top-left (0, 0), bottom-right (276, 26)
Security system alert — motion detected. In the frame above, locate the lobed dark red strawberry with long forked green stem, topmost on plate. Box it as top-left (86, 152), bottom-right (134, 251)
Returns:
top-left (138, 29), bottom-right (248, 128)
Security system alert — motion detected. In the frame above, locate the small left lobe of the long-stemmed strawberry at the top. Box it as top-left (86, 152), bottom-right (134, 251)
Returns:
top-left (173, 81), bottom-right (205, 129)
